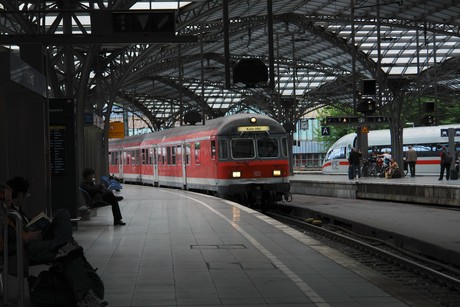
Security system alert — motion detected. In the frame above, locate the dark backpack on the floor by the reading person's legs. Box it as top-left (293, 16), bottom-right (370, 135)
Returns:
top-left (28, 255), bottom-right (104, 307)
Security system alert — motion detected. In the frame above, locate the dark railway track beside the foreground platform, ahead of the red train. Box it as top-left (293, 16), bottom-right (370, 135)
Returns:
top-left (267, 211), bottom-right (460, 307)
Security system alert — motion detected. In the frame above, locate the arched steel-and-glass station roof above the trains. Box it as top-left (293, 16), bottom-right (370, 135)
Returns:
top-left (0, 0), bottom-right (460, 130)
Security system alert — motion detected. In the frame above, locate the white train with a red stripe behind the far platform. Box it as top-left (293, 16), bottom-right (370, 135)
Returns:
top-left (322, 124), bottom-right (460, 175)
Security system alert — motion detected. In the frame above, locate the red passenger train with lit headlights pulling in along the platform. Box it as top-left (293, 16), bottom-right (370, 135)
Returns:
top-left (109, 114), bottom-right (290, 209)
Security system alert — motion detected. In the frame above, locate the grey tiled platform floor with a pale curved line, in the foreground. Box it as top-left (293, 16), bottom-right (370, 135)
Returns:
top-left (10, 185), bottom-right (435, 307)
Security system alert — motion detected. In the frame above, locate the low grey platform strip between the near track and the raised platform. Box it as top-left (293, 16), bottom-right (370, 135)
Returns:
top-left (293, 194), bottom-right (460, 267)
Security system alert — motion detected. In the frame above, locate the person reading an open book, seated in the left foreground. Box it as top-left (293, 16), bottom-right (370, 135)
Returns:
top-left (6, 177), bottom-right (107, 307)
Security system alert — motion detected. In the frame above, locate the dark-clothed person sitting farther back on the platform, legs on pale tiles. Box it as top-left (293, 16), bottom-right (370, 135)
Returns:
top-left (80, 168), bottom-right (126, 226)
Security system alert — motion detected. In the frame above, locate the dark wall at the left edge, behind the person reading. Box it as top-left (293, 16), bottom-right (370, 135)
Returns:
top-left (0, 75), bottom-right (50, 216)
